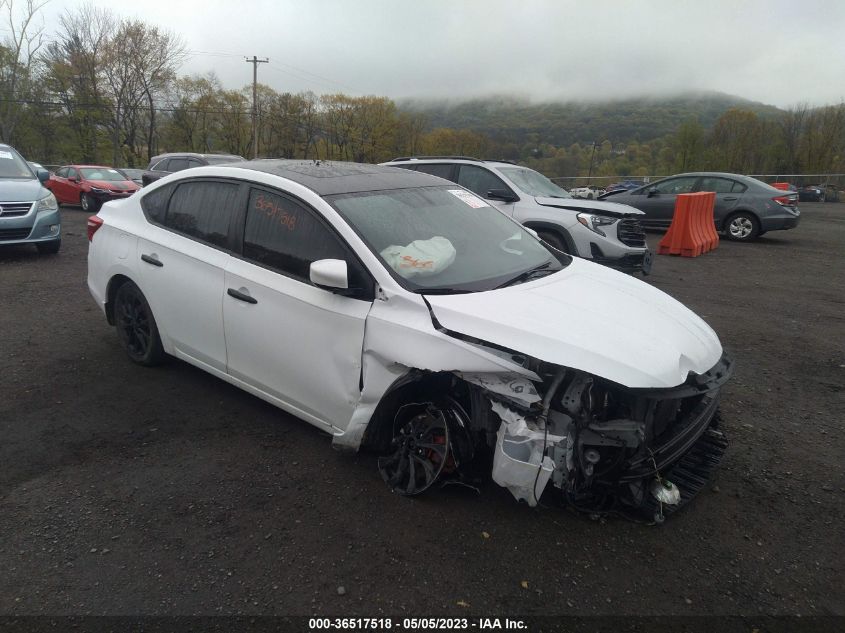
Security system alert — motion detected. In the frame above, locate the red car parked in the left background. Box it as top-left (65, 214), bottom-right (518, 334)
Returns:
top-left (44, 165), bottom-right (140, 213)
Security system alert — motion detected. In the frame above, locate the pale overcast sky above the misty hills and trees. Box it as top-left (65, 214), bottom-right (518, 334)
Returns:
top-left (33, 0), bottom-right (845, 107)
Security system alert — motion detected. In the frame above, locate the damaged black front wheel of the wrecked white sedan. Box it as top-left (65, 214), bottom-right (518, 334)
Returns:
top-left (378, 402), bottom-right (458, 495)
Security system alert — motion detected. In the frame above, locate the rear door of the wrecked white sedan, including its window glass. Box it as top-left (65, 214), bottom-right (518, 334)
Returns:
top-left (138, 179), bottom-right (246, 372)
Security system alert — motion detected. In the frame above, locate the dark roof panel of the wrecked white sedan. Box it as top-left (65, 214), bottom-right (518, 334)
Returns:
top-left (218, 159), bottom-right (445, 196)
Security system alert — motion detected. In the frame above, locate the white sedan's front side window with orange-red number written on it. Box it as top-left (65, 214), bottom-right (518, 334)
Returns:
top-left (243, 184), bottom-right (371, 288)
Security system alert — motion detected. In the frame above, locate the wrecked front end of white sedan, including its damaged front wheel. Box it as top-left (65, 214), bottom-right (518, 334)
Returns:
top-left (372, 355), bottom-right (732, 522)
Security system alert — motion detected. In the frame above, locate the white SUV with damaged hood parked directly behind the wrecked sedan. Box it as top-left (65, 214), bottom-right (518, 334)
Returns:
top-left (382, 156), bottom-right (652, 274)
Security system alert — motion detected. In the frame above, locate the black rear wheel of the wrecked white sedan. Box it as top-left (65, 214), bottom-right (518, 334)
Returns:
top-left (114, 281), bottom-right (164, 367)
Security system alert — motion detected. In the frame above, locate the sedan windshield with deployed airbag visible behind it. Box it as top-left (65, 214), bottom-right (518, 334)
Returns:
top-left (327, 185), bottom-right (570, 294)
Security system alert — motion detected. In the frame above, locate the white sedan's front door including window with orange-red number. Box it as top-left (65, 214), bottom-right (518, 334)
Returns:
top-left (223, 186), bottom-right (373, 428)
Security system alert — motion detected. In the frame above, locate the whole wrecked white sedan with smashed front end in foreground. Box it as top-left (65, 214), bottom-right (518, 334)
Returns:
top-left (88, 160), bottom-right (731, 520)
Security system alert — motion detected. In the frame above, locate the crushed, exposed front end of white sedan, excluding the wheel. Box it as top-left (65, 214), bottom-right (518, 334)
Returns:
top-left (482, 355), bottom-right (732, 522)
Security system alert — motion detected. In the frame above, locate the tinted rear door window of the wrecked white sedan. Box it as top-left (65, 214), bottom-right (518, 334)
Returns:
top-left (163, 181), bottom-right (240, 247)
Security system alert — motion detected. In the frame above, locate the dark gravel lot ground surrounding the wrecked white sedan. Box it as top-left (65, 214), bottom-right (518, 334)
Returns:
top-left (0, 203), bottom-right (845, 618)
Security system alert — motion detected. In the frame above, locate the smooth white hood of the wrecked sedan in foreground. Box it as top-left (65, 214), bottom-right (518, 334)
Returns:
top-left (426, 258), bottom-right (722, 388)
